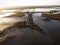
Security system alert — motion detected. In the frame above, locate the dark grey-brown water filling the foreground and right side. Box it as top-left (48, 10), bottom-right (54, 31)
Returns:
top-left (0, 14), bottom-right (60, 45)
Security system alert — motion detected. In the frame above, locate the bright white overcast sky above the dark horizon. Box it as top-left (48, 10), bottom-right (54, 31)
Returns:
top-left (0, 0), bottom-right (60, 7)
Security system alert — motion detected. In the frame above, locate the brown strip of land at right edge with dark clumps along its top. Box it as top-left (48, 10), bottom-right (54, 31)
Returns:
top-left (42, 11), bottom-right (60, 20)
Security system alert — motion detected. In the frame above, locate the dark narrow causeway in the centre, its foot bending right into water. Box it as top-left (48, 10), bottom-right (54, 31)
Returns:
top-left (27, 12), bottom-right (42, 31)
